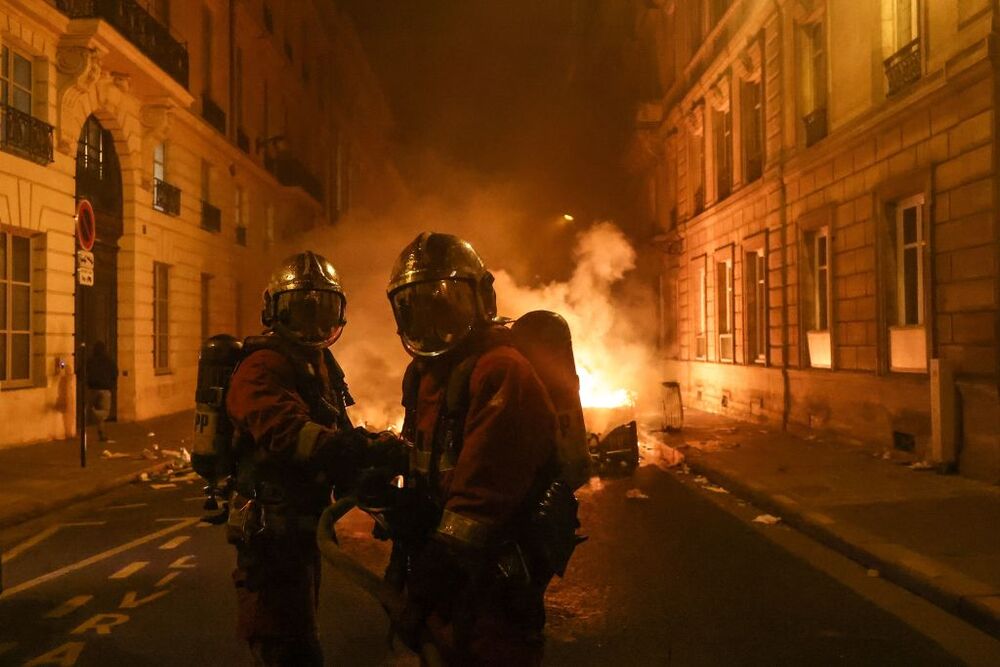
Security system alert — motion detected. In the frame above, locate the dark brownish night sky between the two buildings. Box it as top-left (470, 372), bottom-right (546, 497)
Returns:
top-left (340, 0), bottom-right (630, 230)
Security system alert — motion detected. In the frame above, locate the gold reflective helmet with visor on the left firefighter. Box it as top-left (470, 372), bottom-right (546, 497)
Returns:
top-left (260, 250), bottom-right (347, 350)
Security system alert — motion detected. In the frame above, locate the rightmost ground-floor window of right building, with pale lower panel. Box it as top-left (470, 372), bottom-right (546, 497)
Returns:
top-left (889, 195), bottom-right (927, 372)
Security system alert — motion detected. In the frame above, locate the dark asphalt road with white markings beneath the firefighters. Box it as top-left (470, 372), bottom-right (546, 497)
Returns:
top-left (0, 465), bottom-right (1000, 666)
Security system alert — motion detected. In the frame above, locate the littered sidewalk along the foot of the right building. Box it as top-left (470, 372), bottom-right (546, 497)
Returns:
top-left (664, 409), bottom-right (1000, 637)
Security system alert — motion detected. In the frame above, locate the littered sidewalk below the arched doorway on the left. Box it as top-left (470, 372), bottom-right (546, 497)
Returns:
top-left (0, 411), bottom-right (194, 527)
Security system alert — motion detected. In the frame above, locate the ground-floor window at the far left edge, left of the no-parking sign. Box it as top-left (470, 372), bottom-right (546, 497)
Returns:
top-left (0, 231), bottom-right (32, 386)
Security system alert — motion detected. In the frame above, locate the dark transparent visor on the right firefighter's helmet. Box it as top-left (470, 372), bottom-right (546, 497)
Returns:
top-left (391, 280), bottom-right (476, 357)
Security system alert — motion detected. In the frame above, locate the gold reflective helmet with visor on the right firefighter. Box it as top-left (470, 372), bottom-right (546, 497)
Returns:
top-left (386, 232), bottom-right (497, 358)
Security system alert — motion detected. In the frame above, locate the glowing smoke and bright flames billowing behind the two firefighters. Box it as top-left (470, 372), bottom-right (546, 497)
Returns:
top-left (268, 174), bottom-right (652, 434)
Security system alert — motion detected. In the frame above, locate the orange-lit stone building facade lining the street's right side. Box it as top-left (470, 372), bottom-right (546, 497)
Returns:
top-left (633, 0), bottom-right (1000, 482)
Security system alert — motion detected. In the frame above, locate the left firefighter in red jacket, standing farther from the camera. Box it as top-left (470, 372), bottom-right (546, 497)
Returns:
top-left (226, 252), bottom-right (398, 666)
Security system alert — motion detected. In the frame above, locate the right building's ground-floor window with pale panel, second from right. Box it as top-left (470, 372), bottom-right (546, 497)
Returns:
top-left (804, 226), bottom-right (833, 368)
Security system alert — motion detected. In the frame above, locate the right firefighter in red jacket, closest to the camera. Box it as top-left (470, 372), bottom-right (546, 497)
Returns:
top-left (388, 233), bottom-right (557, 665)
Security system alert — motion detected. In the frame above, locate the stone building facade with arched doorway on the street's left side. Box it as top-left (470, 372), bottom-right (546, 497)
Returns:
top-left (0, 0), bottom-right (398, 447)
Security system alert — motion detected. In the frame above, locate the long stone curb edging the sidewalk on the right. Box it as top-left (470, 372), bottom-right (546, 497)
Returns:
top-left (685, 456), bottom-right (1000, 639)
